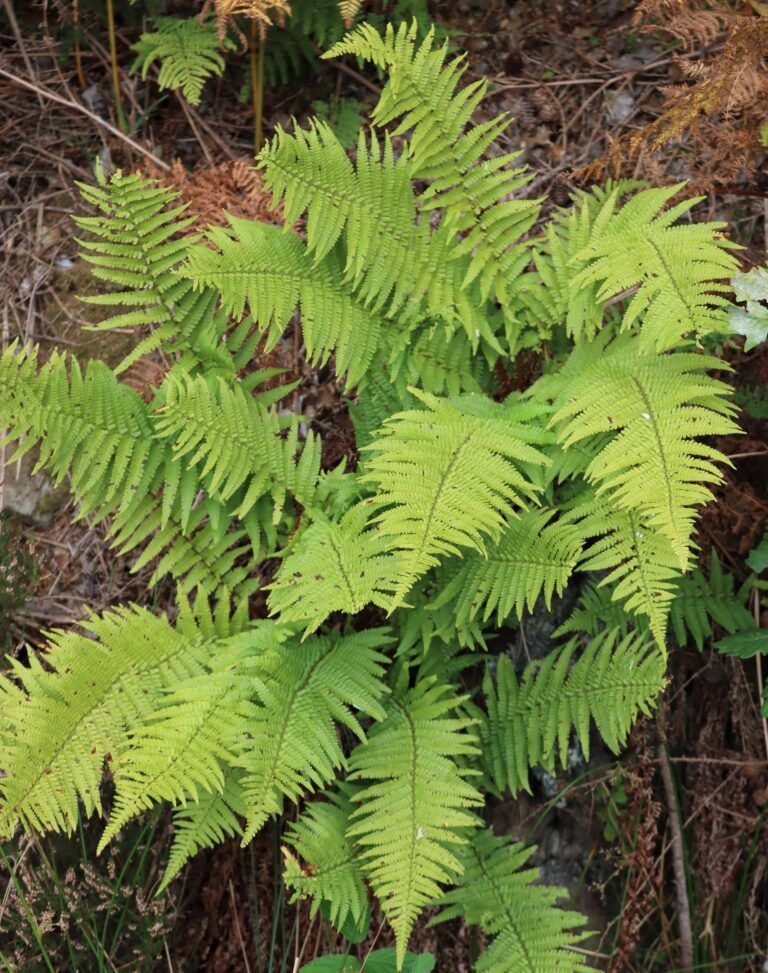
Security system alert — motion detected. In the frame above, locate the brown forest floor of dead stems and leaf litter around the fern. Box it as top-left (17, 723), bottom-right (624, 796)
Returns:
top-left (0, 0), bottom-right (768, 973)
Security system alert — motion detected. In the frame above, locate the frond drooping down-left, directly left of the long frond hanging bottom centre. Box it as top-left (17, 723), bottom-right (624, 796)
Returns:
top-left (238, 629), bottom-right (389, 844)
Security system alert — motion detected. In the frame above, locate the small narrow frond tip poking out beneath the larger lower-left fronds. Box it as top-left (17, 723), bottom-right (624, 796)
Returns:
top-left (157, 771), bottom-right (245, 895)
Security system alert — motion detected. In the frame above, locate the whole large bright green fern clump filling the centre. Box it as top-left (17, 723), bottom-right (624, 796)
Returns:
top-left (0, 19), bottom-right (743, 973)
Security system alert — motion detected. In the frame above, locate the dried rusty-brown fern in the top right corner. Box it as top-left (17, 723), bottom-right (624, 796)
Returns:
top-left (578, 0), bottom-right (768, 189)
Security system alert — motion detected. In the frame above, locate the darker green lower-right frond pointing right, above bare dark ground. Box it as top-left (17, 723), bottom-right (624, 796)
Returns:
top-left (481, 631), bottom-right (665, 794)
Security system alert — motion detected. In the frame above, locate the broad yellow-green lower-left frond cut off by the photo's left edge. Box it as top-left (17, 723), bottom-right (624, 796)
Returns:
top-left (0, 607), bottom-right (248, 833)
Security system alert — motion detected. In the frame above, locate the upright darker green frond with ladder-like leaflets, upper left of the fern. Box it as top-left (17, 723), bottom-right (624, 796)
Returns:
top-left (75, 170), bottom-right (232, 374)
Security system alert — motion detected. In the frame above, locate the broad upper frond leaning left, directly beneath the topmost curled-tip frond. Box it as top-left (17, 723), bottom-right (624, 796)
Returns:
top-left (259, 121), bottom-right (494, 342)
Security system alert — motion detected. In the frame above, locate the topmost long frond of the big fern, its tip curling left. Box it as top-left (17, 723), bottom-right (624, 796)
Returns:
top-left (324, 21), bottom-right (540, 300)
